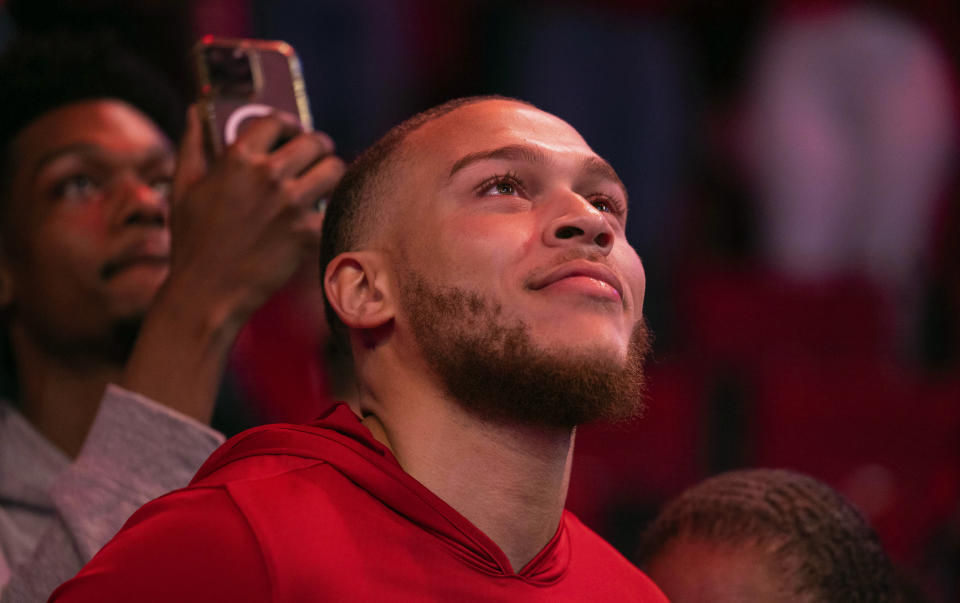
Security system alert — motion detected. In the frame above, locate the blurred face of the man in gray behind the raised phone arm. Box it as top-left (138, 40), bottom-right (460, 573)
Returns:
top-left (2, 100), bottom-right (174, 354)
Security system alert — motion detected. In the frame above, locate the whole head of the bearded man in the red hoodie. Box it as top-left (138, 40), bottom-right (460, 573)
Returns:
top-left (321, 97), bottom-right (648, 429)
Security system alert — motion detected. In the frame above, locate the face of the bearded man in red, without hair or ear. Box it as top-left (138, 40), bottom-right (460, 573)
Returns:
top-left (388, 101), bottom-right (645, 423)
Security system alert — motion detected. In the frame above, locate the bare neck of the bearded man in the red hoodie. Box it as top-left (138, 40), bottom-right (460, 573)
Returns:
top-left (361, 364), bottom-right (574, 571)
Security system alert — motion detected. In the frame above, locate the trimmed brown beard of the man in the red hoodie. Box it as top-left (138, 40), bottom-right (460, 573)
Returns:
top-left (400, 270), bottom-right (650, 428)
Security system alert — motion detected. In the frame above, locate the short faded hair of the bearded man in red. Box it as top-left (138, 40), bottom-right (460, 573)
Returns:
top-left (320, 95), bottom-right (533, 350)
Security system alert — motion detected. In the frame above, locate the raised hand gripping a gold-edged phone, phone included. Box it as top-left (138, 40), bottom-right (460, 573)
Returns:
top-left (162, 39), bottom-right (345, 323)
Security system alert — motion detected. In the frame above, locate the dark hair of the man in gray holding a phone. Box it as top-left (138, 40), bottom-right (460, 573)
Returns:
top-left (0, 32), bottom-right (186, 208)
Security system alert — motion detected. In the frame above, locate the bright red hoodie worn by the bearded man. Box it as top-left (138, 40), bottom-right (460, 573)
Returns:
top-left (51, 405), bottom-right (666, 602)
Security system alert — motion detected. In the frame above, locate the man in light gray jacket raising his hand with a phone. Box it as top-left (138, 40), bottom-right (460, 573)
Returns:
top-left (0, 34), bottom-right (344, 601)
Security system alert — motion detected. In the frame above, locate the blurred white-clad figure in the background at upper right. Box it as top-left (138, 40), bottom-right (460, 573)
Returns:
top-left (735, 3), bottom-right (958, 332)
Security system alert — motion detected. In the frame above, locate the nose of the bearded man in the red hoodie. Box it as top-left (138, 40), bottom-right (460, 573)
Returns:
top-left (544, 191), bottom-right (614, 255)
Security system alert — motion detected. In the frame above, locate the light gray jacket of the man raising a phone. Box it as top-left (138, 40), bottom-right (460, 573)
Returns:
top-left (0, 385), bottom-right (224, 603)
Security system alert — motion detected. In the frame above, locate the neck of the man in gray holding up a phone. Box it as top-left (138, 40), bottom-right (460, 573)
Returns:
top-left (10, 326), bottom-right (123, 458)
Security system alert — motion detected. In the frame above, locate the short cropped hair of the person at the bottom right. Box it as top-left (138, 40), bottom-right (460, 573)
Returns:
top-left (638, 469), bottom-right (899, 603)
